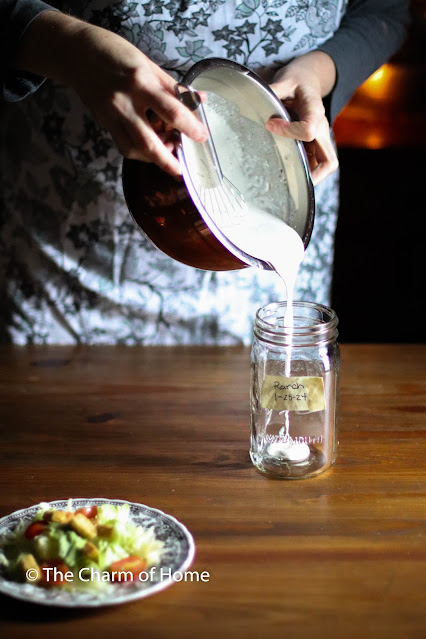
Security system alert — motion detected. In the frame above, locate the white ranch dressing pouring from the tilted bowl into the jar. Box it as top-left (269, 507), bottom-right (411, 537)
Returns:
top-left (184, 96), bottom-right (310, 462)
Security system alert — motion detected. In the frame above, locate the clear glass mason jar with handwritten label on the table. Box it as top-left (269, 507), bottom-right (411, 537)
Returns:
top-left (250, 302), bottom-right (340, 479)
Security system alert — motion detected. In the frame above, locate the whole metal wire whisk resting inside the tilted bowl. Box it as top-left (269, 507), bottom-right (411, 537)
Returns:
top-left (176, 84), bottom-right (247, 228)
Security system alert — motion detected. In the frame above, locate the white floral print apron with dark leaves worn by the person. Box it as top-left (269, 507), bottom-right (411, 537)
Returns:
top-left (0, 0), bottom-right (346, 344)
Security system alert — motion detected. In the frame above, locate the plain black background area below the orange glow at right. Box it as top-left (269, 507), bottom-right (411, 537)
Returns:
top-left (332, 148), bottom-right (426, 342)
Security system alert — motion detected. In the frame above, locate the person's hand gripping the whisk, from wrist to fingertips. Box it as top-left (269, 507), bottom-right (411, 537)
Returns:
top-left (65, 25), bottom-right (207, 175)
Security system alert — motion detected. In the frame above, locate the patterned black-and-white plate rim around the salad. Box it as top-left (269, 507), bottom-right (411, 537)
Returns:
top-left (0, 498), bottom-right (195, 608)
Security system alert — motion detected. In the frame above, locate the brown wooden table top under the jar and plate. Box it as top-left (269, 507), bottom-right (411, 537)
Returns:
top-left (0, 345), bottom-right (426, 639)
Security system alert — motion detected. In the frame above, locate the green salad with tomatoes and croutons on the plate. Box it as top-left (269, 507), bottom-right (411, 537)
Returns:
top-left (0, 500), bottom-right (164, 589)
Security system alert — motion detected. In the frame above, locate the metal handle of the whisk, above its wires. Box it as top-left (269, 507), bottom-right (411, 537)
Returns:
top-left (175, 83), bottom-right (223, 188)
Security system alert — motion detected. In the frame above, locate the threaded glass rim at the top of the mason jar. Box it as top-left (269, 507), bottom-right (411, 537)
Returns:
top-left (254, 302), bottom-right (339, 342)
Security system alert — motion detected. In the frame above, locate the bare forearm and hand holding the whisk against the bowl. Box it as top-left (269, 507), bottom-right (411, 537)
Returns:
top-left (13, 11), bottom-right (207, 175)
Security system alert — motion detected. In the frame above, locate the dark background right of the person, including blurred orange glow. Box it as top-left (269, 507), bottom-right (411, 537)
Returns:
top-left (332, 0), bottom-right (426, 342)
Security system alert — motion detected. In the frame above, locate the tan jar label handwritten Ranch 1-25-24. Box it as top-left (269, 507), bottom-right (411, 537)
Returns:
top-left (260, 375), bottom-right (325, 413)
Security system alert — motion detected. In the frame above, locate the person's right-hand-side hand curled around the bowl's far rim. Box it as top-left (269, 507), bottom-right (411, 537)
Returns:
top-left (266, 51), bottom-right (339, 186)
